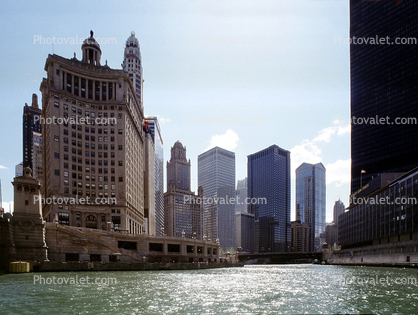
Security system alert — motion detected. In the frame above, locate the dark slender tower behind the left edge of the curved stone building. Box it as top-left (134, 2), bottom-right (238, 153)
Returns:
top-left (23, 94), bottom-right (42, 169)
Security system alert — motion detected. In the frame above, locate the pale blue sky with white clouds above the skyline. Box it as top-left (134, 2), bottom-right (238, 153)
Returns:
top-left (0, 0), bottom-right (351, 222)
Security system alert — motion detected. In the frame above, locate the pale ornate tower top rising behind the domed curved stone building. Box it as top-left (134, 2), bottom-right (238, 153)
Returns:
top-left (122, 32), bottom-right (144, 106)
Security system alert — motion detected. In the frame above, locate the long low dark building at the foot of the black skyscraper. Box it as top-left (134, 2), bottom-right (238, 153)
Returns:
top-left (338, 168), bottom-right (418, 254)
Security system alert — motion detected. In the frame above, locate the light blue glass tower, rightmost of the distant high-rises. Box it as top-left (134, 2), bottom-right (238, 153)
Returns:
top-left (296, 163), bottom-right (326, 251)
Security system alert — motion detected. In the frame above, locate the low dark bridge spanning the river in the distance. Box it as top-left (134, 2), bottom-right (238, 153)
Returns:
top-left (238, 252), bottom-right (322, 264)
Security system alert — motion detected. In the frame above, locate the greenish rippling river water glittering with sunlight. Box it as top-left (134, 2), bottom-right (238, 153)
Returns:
top-left (0, 264), bottom-right (418, 314)
